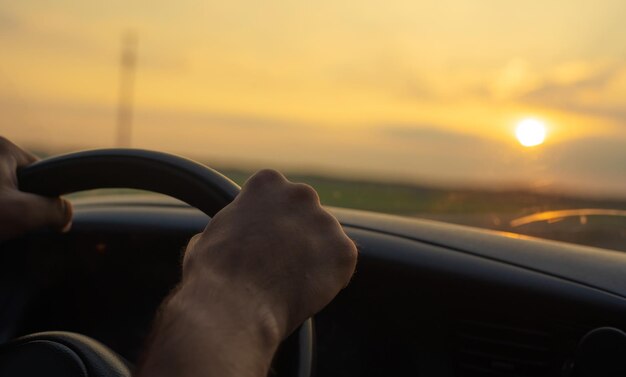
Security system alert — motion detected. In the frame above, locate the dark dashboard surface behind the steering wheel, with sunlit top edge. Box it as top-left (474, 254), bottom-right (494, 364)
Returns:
top-left (0, 201), bottom-right (626, 376)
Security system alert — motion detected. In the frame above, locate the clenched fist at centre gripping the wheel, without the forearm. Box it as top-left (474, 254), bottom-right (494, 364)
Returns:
top-left (183, 170), bottom-right (357, 337)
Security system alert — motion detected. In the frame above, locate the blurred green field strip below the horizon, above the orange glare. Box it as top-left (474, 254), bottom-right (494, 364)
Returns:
top-left (221, 169), bottom-right (626, 216)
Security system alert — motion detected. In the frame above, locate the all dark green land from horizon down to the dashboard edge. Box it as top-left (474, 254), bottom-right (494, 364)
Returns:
top-left (222, 169), bottom-right (626, 251)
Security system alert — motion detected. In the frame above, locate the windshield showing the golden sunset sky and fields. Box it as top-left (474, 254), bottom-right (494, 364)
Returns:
top-left (0, 0), bottom-right (626, 250)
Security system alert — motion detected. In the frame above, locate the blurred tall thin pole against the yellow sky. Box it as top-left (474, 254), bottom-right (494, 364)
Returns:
top-left (116, 31), bottom-right (138, 148)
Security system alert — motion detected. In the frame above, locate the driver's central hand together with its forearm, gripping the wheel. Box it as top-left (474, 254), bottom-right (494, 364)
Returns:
top-left (137, 170), bottom-right (357, 377)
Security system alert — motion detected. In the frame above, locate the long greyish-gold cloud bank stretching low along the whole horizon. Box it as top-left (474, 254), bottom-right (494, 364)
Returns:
top-left (6, 93), bottom-right (626, 196)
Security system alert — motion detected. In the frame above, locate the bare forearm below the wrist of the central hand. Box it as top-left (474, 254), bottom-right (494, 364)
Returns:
top-left (137, 284), bottom-right (281, 377)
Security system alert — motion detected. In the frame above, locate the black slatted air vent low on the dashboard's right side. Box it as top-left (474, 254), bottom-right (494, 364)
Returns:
top-left (454, 321), bottom-right (575, 377)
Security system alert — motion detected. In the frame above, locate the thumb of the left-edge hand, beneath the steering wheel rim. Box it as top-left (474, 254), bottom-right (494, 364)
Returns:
top-left (15, 191), bottom-right (72, 233)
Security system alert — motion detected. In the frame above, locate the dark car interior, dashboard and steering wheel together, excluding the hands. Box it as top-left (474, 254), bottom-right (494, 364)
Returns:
top-left (0, 150), bottom-right (626, 377)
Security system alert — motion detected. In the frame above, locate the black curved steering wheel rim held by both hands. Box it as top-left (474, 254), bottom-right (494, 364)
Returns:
top-left (18, 149), bottom-right (314, 377)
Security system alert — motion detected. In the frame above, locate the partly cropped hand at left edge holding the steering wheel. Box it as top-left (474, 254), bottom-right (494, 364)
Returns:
top-left (0, 136), bottom-right (72, 241)
